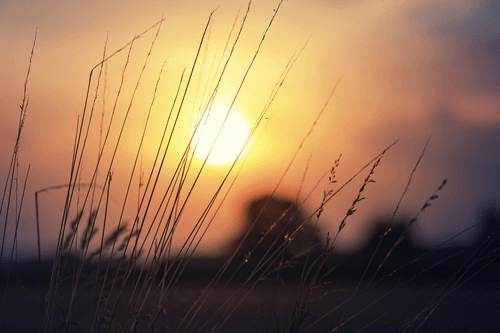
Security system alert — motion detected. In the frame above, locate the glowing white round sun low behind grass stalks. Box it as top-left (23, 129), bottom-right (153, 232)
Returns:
top-left (193, 105), bottom-right (254, 165)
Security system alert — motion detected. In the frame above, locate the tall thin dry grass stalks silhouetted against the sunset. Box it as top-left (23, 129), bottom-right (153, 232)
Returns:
top-left (0, 3), bottom-right (498, 332)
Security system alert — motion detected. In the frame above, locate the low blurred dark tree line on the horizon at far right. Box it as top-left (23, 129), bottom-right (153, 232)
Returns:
top-left (341, 205), bottom-right (500, 284)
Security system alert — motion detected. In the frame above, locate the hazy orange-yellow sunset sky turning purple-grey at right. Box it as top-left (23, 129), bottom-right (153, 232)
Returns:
top-left (0, 0), bottom-right (500, 256)
